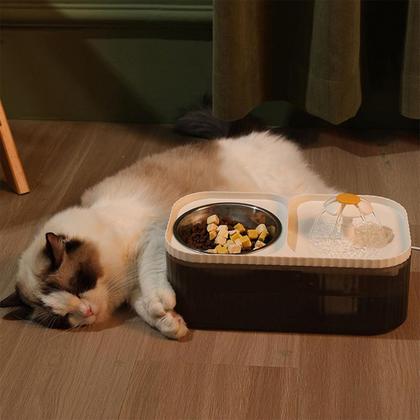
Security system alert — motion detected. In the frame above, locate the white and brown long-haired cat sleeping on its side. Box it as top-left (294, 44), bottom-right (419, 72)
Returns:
top-left (0, 110), bottom-right (333, 338)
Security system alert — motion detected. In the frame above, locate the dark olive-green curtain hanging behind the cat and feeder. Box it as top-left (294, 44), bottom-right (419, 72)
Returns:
top-left (213, 0), bottom-right (420, 124)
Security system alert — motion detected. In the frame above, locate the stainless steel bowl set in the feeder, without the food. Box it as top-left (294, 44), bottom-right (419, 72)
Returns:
top-left (174, 202), bottom-right (282, 253)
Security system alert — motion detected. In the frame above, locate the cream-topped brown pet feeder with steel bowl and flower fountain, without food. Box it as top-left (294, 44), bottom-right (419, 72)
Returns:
top-left (166, 192), bottom-right (411, 334)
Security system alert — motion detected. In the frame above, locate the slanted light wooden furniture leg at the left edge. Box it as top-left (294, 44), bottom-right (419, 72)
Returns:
top-left (0, 101), bottom-right (29, 194)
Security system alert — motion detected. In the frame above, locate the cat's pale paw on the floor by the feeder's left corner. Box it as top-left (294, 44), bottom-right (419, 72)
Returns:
top-left (134, 288), bottom-right (188, 340)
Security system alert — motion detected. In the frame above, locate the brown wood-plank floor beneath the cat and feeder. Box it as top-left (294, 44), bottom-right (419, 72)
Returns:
top-left (0, 121), bottom-right (420, 420)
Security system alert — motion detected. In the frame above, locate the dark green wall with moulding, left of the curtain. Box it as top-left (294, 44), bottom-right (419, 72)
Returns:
top-left (0, 0), bottom-right (212, 123)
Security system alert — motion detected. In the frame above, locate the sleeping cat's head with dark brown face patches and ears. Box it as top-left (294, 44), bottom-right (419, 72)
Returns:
top-left (0, 232), bottom-right (108, 328)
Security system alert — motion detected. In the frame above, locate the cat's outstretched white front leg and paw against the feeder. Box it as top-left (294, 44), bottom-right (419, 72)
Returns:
top-left (131, 223), bottom-right (188, 339)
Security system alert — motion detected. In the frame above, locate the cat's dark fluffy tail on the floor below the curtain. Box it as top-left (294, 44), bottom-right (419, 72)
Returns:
top-left (174, 98), bottom-right (266, 139)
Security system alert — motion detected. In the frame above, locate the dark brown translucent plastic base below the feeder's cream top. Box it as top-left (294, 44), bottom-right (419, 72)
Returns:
top-left (167, 254), bottom-right (410, 334)
